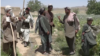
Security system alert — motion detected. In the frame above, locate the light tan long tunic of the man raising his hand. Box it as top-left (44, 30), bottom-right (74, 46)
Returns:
top-left (60, 14), bottom-right (79, 38)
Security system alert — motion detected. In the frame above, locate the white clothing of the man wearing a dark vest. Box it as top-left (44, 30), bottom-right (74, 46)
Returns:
top-left (21, 14), bottom-right (34, 42)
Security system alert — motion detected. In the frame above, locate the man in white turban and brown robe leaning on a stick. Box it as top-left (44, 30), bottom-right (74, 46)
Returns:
top-left (2, 5), bottom-right (17, 56)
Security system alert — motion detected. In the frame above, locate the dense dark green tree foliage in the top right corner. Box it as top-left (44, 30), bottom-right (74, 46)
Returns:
top-left (87, 0), bottom-right (100, 15)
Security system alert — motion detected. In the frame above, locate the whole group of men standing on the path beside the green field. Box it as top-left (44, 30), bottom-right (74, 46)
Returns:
top-left (2, 5), bottom-right (96, 56)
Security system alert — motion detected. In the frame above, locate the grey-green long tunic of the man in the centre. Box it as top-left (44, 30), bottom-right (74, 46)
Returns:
top-left (39, 16), bottom-right (51, 42)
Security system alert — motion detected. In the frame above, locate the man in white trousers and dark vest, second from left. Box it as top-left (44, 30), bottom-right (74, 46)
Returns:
top-left (21, 8), bottom-right (33, 47)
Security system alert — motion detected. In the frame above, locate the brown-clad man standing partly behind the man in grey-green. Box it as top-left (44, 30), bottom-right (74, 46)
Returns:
top-left (45, 5), bottom-right (55, 51)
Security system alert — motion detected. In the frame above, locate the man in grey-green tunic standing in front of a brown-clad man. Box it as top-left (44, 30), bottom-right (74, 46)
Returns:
top-left (37, 8), bottom-right (51, 54)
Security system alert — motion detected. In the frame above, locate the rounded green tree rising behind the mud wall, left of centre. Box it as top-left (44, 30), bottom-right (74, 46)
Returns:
top-left (27, 0), bottom-right (42, 12)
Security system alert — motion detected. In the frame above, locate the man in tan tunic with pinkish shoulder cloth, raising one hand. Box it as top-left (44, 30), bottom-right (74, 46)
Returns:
top-left (58, 7), bottom-right (79, 55)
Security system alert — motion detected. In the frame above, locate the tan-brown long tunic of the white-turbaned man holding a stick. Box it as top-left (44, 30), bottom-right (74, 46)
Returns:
top-left (2, 15), bottom-right (17, 43)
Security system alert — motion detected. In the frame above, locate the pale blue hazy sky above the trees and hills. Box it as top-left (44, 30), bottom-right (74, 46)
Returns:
top-left (0, 0), bottom-right (100, 8)
